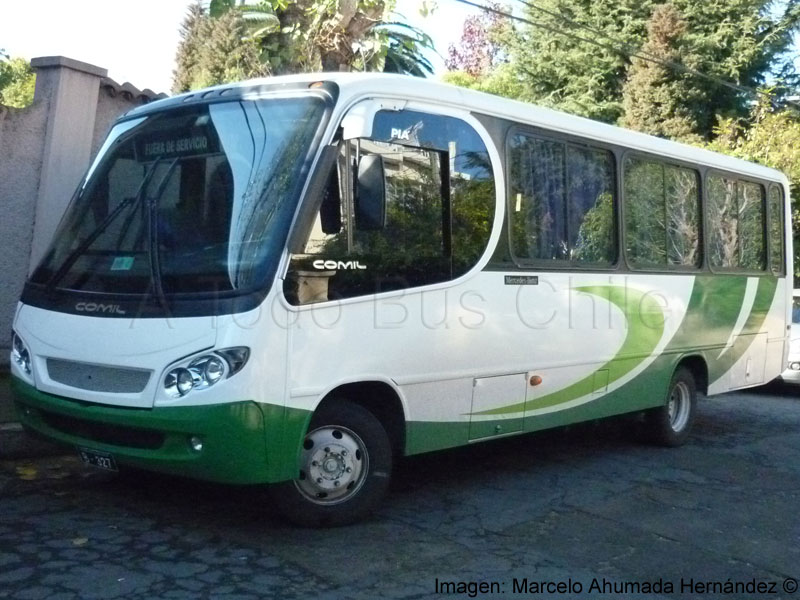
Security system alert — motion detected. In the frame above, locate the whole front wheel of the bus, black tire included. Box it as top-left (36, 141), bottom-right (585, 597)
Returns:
top-left (270, 400), bottom-right (392, 527)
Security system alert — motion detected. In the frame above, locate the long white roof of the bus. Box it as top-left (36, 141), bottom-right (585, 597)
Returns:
top-left (131, 73), bottom-right (789, 186)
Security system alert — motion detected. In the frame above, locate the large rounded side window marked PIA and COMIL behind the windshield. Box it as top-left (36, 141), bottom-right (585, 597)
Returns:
top-left (284, 111), bottom-right (495, 304)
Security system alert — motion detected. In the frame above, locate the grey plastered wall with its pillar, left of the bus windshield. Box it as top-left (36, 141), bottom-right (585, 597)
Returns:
top-left (0, 56), bottom-right (163, 369)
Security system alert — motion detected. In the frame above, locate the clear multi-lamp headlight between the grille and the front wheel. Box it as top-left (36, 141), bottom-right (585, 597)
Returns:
top-left (164, 347), bottom-right (250, 398)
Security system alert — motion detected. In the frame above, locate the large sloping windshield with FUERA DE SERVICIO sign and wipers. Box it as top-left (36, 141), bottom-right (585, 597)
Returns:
top-left (31, 96), bottom-right (324, 294)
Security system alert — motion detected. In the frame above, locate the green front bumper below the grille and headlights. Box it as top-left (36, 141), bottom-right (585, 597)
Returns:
top-left (11, 377), bottom-right (282, 484)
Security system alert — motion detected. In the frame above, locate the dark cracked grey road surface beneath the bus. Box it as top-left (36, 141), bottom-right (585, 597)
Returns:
top-left (0, 388), bottom-right (800, 600)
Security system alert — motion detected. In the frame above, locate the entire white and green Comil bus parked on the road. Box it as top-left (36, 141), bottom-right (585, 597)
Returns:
top-left (11, 74), bottom-right (792, 525)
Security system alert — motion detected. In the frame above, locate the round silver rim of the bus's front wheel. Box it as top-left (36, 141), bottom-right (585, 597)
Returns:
top-left (294, 426), bottom-right (369, 504)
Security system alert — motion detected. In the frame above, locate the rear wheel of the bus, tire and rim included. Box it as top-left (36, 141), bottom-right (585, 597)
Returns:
top-left (644, 367), bottom-right (697, 447)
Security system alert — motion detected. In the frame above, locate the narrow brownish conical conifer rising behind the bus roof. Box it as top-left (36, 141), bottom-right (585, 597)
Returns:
top-left (621, 4), bottom-right (712, 142)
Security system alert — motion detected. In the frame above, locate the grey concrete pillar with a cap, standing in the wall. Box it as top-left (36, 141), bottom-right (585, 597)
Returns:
top-left (29, 56), bottom-right (107, 272)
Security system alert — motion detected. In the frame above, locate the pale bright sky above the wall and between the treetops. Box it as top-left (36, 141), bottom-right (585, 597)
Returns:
top-left (0, 0), bottom-right (476, 93)
